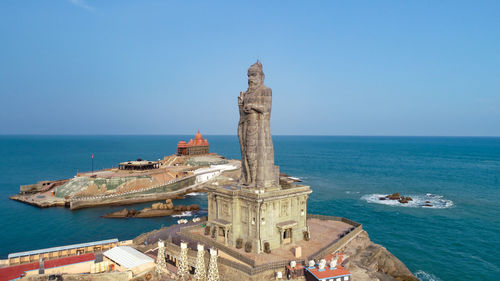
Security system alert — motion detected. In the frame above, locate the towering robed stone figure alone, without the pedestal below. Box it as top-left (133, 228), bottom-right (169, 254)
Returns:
top-left (238, 61), bottom-right (279, 188)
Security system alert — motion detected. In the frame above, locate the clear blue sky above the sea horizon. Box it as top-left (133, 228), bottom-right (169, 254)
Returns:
top-left (0, 0), bottom-right (500, 136)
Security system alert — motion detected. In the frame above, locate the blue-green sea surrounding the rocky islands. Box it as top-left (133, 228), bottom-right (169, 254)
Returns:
top-left (0, 136), bottom-right (500, 280)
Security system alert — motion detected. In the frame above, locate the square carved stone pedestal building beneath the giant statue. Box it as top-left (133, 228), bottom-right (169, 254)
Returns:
top-left (207, 185), bottom-right (312, 253)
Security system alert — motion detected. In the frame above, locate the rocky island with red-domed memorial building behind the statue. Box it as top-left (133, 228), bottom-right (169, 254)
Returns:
top-left (10, 139), bottom-right (240, 210)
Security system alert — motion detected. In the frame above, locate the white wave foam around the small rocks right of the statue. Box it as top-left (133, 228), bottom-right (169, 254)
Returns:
top-left (361, 193), bottom-right (453, 209)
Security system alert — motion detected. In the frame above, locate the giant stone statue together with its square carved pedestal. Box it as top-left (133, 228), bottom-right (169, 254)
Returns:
top-left (205, 61), bottom-right (312, 254)
